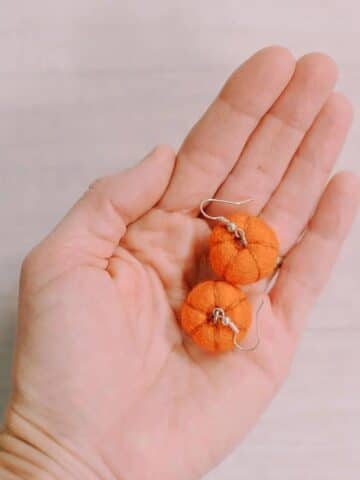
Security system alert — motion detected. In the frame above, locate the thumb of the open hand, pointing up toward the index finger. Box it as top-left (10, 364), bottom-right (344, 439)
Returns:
top-left (54, 145), bottom-right (175, 246)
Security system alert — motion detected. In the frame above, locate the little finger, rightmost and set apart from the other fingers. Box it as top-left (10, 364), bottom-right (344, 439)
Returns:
top-left (270, 172), bottom-right (360, 334)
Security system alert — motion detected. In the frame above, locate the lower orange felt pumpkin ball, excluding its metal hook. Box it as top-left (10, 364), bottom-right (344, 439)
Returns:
top-left (180, 280), bottom-right (251, 352)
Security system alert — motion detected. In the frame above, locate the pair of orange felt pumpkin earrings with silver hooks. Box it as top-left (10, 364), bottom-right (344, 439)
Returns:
top-left (180, 198), bottom-right (279, 353)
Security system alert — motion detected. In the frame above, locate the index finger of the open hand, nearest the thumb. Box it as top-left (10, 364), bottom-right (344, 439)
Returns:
top-left (160, 47), bottom-right (295, 214)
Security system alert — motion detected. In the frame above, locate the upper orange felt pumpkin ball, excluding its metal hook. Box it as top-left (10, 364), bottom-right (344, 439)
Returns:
top-left (209, 212), bottom-right (279, 285)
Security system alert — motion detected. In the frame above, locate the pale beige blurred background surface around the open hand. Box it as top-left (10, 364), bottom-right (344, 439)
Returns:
top-left (0, 0), bottom-right (360, 480)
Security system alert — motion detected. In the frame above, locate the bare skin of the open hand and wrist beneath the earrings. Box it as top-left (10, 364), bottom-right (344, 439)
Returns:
top-left (0, 47), bottom-right (360, 480)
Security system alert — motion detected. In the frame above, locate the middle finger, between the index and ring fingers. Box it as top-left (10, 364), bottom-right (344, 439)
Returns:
top-left (212, 53), bottom-right (337, 214)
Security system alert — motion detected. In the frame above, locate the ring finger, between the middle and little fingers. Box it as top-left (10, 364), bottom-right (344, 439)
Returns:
top-left (261, 93), bottom-right (352, 254)
